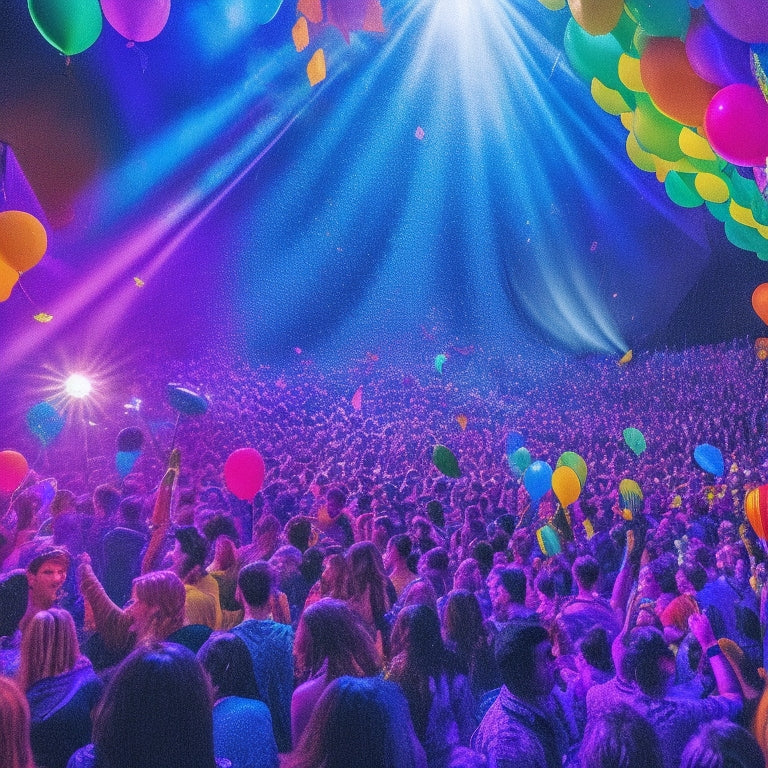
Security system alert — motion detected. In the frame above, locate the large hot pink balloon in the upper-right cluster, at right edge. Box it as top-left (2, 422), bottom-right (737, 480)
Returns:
top-left (704, 83), bottom-right (768, 166)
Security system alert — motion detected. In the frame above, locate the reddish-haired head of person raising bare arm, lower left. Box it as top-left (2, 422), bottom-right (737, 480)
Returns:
top-left (125, 571), bottom-right (187, 642)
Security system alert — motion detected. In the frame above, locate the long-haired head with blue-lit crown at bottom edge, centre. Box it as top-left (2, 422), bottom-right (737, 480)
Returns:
top-left (287, 677), bottom-right (424, 768)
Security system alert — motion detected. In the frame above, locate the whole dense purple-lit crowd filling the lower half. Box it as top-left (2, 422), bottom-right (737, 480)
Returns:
top-left (0, 342), bottom-right (768, 768)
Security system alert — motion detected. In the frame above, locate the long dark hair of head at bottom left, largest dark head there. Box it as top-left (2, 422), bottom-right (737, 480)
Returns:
top-left (93, 643), bottom-right (215, 768)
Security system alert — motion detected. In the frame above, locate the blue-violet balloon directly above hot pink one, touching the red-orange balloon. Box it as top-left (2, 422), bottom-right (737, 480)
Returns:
top-left (685, 8), bottom-right (755, 87)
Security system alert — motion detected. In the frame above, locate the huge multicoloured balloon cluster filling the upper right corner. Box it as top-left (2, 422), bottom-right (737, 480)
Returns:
top-left (540, 0), bottom-right (768, 260)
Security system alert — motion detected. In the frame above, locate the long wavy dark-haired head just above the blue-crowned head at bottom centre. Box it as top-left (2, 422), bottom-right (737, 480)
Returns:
top-left (293, 598), bottom-right (381, 680)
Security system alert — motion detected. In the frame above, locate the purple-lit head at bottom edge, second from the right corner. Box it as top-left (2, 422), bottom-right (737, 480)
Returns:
top-left (579, 704), bottom-right (664, 768)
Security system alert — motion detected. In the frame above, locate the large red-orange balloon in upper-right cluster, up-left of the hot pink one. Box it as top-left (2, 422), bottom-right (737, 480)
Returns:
top-left (640, 37), bottom-right (718, 127)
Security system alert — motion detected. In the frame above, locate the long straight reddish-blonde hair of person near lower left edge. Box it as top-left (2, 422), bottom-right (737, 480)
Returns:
top-left (19, 608), bottom-right (80, 691)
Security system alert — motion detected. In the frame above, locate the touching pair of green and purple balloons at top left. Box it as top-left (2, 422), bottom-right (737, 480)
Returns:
top-left (28, 0), bottom-right (171, 56)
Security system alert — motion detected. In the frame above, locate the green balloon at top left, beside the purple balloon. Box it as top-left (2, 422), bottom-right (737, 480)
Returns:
top-left (27, 0), bottom-right (102, 56)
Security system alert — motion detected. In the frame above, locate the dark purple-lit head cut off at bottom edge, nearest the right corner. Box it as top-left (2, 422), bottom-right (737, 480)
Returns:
top-left (680, 720), bottom-right (765, 768)
